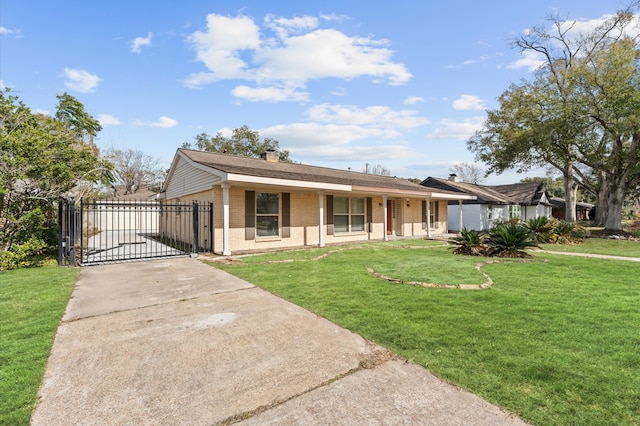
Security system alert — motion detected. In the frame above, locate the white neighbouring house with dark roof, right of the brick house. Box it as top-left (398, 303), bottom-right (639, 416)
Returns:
top-left (420, 175), bottom-right (551, 232)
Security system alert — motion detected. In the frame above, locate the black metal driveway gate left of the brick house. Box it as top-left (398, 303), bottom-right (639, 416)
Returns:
top-left (58, 199), bottom-right (214, 266)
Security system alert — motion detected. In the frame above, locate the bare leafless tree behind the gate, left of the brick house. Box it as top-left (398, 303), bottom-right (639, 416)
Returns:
top-left (104, 148), bottom-right (166, 195)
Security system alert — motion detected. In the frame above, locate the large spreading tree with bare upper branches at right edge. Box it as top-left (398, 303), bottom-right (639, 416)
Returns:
top-left (469, 5), bottom-right (640, 231)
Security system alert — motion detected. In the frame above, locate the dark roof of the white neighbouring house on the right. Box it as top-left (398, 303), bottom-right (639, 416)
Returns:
top-left (420, 177), bottom-right (547, 206)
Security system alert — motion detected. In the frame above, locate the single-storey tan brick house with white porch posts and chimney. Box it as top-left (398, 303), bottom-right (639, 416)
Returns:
top-left (162, 149), bottom-right (474, 255)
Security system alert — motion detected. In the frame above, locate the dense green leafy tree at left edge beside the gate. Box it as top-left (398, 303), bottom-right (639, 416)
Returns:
top-left (0, 89), bottom-right (109, 260)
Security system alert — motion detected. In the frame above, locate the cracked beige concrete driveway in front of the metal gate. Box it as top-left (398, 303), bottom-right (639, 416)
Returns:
top-left (32, 258), bottom-right (524, 426)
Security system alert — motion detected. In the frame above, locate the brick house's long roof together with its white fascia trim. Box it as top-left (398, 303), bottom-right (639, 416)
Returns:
top-left (168, 148), bottom-right (472, 199)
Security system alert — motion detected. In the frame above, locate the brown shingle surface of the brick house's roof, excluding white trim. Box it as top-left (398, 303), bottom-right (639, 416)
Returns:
top-left (179, 148), bottom-right (431, 193)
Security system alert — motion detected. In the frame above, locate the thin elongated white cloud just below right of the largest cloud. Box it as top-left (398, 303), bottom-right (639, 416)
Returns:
top-left (307, 104), bottom-right (429, 129)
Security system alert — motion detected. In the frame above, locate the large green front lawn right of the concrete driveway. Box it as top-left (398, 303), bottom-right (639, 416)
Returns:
top-left (216, 241), bottom-right (640, 425)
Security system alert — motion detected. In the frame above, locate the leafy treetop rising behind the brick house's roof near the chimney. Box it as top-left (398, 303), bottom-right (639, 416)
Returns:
top-left (182, 125), bottom-right (291, 163)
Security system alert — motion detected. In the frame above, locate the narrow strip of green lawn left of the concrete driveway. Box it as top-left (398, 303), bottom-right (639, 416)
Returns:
top-left (0, 266), bottom-right (78, 425)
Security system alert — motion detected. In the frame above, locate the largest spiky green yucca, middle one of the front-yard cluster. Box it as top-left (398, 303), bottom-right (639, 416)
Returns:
top-left (486, 224), bottom-right (538, 258)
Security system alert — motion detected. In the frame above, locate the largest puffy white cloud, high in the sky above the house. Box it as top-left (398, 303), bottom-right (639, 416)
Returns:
top-left (183, 14), bottom-right (412, 101)
